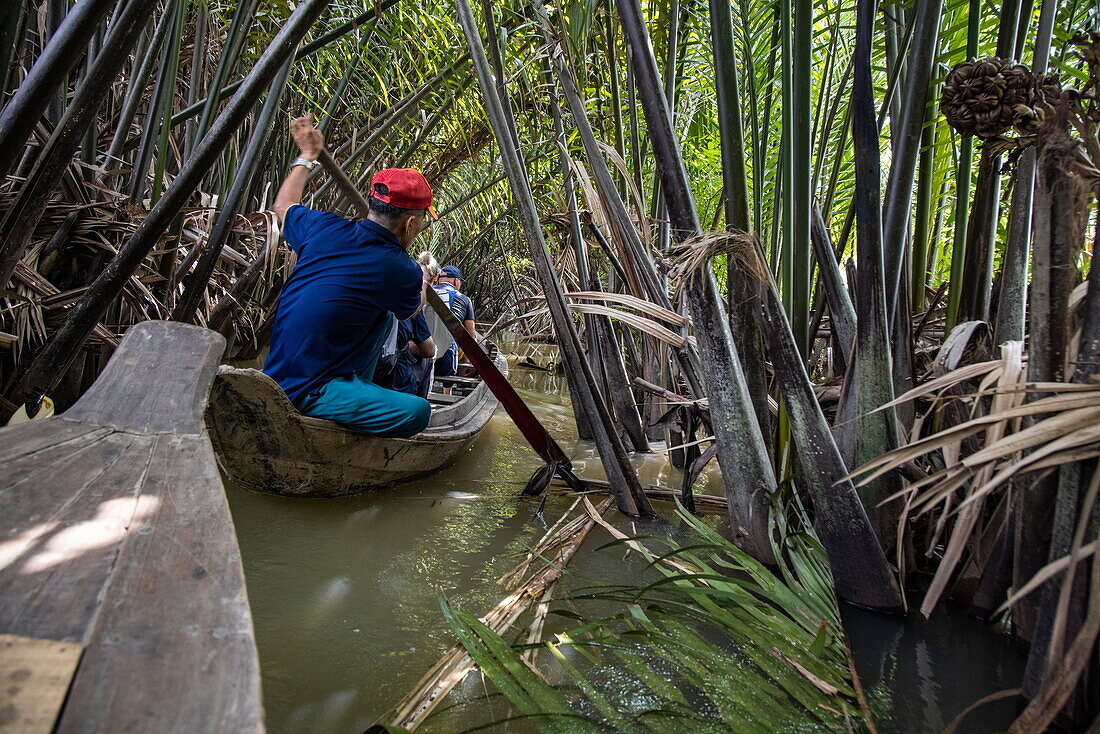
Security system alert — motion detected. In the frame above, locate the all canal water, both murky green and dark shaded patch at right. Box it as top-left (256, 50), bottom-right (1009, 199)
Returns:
top-left (227, 360), bottom-right (1023, 734)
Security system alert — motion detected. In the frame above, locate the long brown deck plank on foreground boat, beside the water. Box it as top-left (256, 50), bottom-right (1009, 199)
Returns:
top-left (58, 436), bottom-right (263, 733)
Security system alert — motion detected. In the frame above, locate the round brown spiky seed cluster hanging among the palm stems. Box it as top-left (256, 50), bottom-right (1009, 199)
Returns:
top-left (939, 57), bottom-right (1043, 140)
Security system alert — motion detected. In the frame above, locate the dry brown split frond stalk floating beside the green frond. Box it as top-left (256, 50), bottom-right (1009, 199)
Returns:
top-left (384, 497), bottom-right (612, 731)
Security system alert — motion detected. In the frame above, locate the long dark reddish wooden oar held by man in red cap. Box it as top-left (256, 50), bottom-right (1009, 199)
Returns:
top-left (318, 150), bottom-right (583, 479)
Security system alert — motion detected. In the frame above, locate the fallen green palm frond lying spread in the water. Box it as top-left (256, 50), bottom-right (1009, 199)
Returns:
top-left (433, 499), bottom-right (873, 732)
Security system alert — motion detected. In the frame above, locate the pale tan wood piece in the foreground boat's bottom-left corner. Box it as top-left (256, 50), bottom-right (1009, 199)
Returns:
top-left (0, 635), bottom-right (84, 734)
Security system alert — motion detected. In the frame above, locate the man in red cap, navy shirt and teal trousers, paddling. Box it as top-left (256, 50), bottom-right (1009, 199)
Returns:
top-left (264, 116), bottom-right (435, 438)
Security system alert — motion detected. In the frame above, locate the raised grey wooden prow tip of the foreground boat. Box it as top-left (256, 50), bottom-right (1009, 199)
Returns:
top-left (65, 321), bottom-right (226, 434)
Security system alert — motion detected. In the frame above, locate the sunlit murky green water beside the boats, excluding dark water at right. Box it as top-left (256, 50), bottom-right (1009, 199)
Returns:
top-left (228, 370), bottom-right (714, 734)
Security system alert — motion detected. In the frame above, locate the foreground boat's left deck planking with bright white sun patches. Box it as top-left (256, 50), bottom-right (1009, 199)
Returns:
top-left (0, 434), bottom-right (156, 642)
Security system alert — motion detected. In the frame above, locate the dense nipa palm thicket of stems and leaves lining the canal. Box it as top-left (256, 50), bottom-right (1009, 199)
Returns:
top-left (0, 0), bottom-right (1100, 732)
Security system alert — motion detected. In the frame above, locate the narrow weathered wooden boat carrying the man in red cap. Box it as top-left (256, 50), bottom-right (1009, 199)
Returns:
top-left (207, 357), bottom-right (507, 497)
